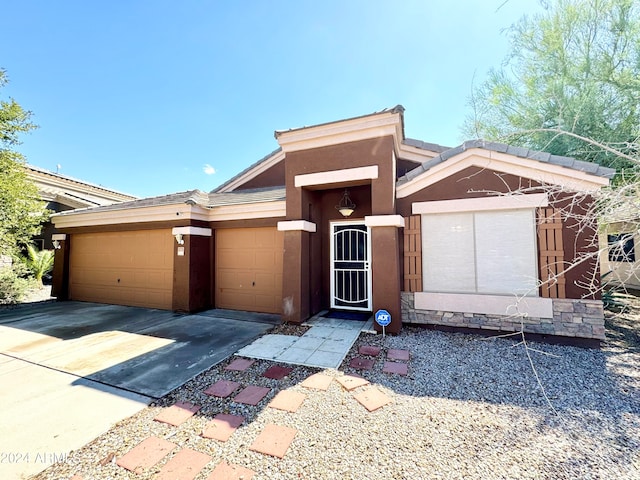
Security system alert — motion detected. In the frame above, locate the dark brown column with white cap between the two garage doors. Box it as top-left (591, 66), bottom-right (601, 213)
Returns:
top-left (171, 227), bottom-right (213, 312)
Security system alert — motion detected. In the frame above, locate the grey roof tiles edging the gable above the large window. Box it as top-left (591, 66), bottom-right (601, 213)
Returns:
top-left (398, 140), bottom-right (616, 185)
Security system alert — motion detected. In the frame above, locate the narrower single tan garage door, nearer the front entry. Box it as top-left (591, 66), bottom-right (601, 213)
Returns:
top-left (216, 227), bottom-right (284, 313)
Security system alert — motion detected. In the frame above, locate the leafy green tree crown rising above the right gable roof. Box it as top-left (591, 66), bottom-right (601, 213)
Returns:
top-left (464, 0), bottom-right (640, 168)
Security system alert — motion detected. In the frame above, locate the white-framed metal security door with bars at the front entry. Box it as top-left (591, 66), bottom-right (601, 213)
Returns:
top-left (331, 222), bottom-right (371, 311)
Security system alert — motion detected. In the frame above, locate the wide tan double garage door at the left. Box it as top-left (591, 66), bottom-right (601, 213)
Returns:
top-left (69, 230), bottom-right (174, 310)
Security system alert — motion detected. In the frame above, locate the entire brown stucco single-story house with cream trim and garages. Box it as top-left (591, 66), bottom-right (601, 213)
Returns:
top-left (53, 106), bottom-right (614, 343)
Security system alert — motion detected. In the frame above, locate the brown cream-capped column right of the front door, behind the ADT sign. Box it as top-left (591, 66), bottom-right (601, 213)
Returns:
top-left (365, 215), bottom-right (404, 333)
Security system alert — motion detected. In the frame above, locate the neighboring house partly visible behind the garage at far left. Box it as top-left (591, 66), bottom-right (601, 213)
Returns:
top-left (25, 165), bottom-right (136, 250)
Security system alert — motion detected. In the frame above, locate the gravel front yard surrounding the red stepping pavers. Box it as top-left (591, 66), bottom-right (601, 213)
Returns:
top-left (28, 304), bottom-right (640, 480)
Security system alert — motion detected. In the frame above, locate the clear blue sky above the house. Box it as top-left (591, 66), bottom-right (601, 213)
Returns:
top-left (0, 0), bottom-right (540, 196)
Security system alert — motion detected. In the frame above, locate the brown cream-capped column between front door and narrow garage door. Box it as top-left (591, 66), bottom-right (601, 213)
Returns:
top-left (278, 220), bottom-right (316, 323)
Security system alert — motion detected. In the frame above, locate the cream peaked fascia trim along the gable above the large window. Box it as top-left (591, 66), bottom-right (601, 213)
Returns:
top-left (396, 148), bottom-right (609, 198)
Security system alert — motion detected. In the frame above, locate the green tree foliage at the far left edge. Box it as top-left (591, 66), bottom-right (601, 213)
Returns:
top-left (0, 69), bottom-right (47, 255)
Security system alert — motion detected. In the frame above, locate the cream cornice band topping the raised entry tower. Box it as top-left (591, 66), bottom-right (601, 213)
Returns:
top-left (276, 112), bottom-right (403, 153)
